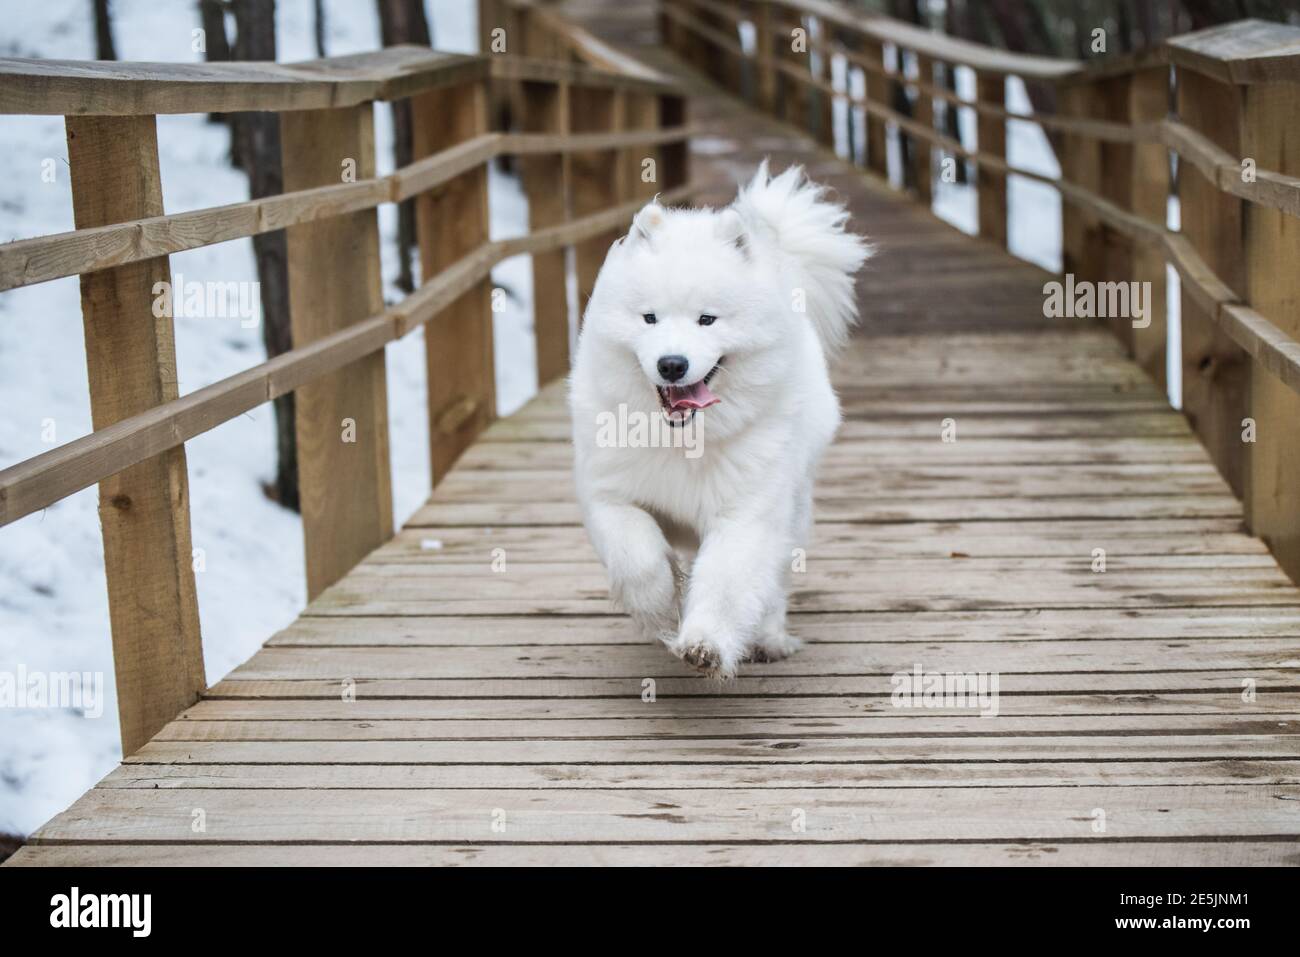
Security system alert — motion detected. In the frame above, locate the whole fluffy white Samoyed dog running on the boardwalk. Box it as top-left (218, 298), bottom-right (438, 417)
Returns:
top-left (569, 161), bottom-right (870, 677)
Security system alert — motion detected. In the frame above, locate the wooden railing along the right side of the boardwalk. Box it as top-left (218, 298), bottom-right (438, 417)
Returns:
top-left (660, 0), bottom-right (1300, 581)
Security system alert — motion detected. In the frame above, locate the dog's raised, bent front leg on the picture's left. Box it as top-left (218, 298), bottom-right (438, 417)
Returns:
top-left (584, 502), bottom-right (679, 641)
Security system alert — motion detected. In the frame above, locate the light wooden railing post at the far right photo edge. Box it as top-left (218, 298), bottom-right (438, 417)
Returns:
top-left (1240, 76), bottom-right (1300, 581)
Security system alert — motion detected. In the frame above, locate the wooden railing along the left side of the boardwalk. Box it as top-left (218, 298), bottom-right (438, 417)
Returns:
top-left (0, 3), bottom-right (690, 754)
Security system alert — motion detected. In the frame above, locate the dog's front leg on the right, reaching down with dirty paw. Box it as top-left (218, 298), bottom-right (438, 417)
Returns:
top-left (670, 505), bottom-right (789, 677)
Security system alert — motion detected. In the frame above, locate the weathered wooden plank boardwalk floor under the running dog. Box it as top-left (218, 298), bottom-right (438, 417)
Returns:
top-left (12, 9), bottom-right (1300, 865)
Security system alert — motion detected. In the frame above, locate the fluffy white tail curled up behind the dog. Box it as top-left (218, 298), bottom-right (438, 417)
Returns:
top-left (735, 160), bottom-right (871, 355)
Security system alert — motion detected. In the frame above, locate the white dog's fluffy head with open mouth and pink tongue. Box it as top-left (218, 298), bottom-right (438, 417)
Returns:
top-left (584, 203), bottom-right (789, 425)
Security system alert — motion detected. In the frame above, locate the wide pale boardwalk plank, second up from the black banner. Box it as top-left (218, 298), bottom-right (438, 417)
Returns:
top-left (36, 785), bottom-right (1300, 843)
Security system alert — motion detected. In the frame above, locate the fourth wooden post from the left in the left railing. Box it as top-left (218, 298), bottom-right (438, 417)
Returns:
top-left (521, 83), bottom-right (569, 385)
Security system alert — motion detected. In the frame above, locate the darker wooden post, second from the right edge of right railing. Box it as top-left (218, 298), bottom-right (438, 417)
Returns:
top-left (1178, 69), bottom-right (1255, 498)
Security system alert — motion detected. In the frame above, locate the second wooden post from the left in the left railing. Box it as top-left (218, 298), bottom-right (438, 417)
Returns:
top-left (281, 104), bottom-right (394, 599)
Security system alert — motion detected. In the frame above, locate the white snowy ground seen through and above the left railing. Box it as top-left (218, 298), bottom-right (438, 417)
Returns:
top-left (0, 0), bottom-right (537, 833)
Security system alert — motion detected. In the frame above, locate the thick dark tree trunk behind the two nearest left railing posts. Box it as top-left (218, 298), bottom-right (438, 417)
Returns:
top-left (234, 0), bottom-right (299, 511)
